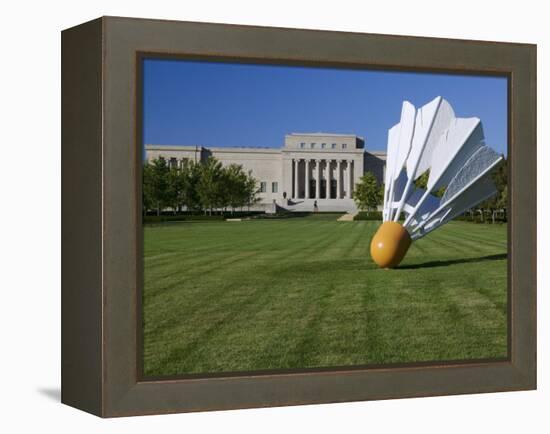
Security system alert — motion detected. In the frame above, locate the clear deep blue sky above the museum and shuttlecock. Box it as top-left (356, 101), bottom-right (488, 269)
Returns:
top-left (143, 59), bottom-right (507, 154)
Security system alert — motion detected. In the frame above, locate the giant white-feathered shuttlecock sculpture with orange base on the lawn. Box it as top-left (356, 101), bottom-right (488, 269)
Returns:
top-left (370, 97), bottom-right (502, 268)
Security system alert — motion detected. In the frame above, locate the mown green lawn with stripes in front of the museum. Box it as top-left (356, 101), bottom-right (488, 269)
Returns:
top-left (143, 215), bottom-right (507, 376)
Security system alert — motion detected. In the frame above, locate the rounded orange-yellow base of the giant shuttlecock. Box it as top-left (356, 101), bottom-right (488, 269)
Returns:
top-left (370, 222), bottom-right (412, 268)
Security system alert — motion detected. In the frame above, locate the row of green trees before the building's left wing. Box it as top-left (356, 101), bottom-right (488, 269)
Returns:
top-left (143, 157), bottom-right (259, 215)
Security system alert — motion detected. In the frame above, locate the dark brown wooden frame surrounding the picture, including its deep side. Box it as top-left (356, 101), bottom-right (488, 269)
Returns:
top-left (62, 17), bottom-right (537, 417)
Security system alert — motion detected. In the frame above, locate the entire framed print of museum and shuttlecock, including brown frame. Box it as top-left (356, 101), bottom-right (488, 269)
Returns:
top-left (62, 17), bottom-right (536, 417)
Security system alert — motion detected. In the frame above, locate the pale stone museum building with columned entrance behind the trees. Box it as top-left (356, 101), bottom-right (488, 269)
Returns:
top-left (145, 133), bottom-right (386, 212)
